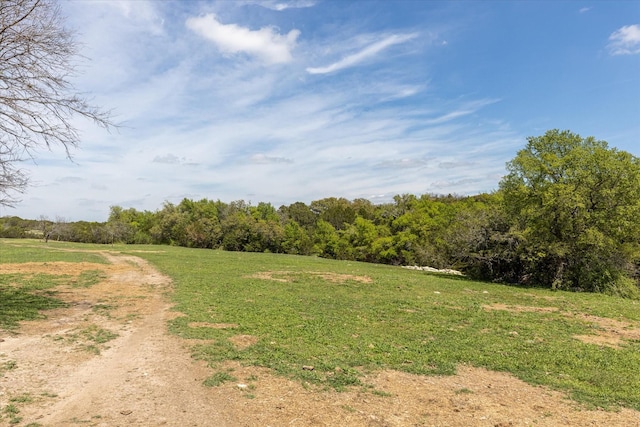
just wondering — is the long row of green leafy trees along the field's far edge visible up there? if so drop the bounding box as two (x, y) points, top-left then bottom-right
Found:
(0, 130), (640, 297)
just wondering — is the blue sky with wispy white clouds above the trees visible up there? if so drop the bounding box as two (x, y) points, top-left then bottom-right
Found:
(6, 0), (640, 221)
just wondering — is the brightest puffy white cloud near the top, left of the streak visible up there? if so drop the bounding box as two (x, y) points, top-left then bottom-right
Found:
(187, 14), (300, 64)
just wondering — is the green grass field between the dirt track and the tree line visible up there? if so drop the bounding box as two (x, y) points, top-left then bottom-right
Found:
(0, 240), (640, 410)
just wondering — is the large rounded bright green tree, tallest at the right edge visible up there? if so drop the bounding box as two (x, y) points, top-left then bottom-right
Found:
(500, 130), (640, 293)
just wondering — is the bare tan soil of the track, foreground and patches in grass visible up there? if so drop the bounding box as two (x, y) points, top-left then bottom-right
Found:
(0, 252), (640, 427)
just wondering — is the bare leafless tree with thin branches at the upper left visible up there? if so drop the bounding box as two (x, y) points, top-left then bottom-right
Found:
(0, 0), (113, 206)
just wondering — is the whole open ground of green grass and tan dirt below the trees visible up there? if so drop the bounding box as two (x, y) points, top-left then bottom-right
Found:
(0, 240), (640, 426)
